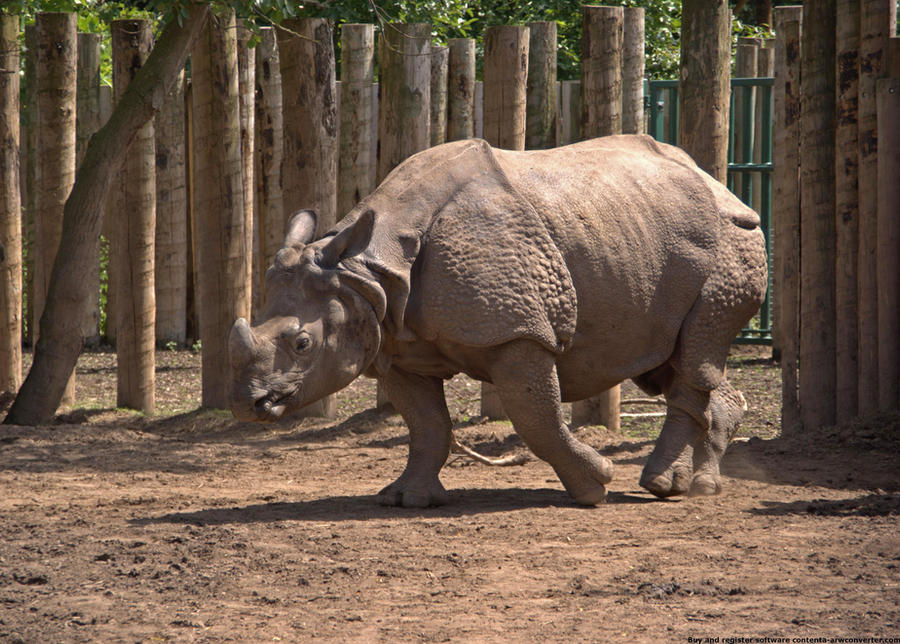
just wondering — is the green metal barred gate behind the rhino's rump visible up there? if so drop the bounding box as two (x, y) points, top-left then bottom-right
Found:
(644, 78), (775, 344)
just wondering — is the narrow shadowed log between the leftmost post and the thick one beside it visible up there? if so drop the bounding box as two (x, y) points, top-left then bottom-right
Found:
(20, 25), (37, 346)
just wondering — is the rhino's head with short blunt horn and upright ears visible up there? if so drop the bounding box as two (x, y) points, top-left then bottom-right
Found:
(229, 210), (381, 421)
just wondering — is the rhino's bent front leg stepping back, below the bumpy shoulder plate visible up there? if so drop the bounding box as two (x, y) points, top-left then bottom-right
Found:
(490, 340), (612, 505)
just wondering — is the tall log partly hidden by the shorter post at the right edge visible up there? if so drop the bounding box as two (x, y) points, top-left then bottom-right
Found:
(857, 0), (897, 415)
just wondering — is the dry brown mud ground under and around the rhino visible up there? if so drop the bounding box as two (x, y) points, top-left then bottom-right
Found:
(0, 348), (900, 642)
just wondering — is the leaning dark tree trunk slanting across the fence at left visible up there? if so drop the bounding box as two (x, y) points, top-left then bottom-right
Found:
(4, 3), (209, 425)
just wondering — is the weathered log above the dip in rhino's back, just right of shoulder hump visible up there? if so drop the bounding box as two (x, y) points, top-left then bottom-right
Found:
(525, 22), (559, 150)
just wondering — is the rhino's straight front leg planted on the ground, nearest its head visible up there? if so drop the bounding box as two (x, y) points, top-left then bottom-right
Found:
(378, 368), (453, 508)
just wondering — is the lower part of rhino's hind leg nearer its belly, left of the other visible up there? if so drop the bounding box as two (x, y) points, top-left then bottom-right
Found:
(641, 375), (711, 498)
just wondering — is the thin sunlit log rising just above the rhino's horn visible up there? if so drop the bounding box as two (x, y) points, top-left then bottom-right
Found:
(237, 20), (259, 320)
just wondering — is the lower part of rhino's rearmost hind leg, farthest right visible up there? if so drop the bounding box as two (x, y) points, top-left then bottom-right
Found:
(689, 380), (747, 496)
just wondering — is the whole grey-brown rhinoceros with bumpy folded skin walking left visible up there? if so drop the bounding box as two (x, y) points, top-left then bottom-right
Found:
(230, 136), (766, 507)
